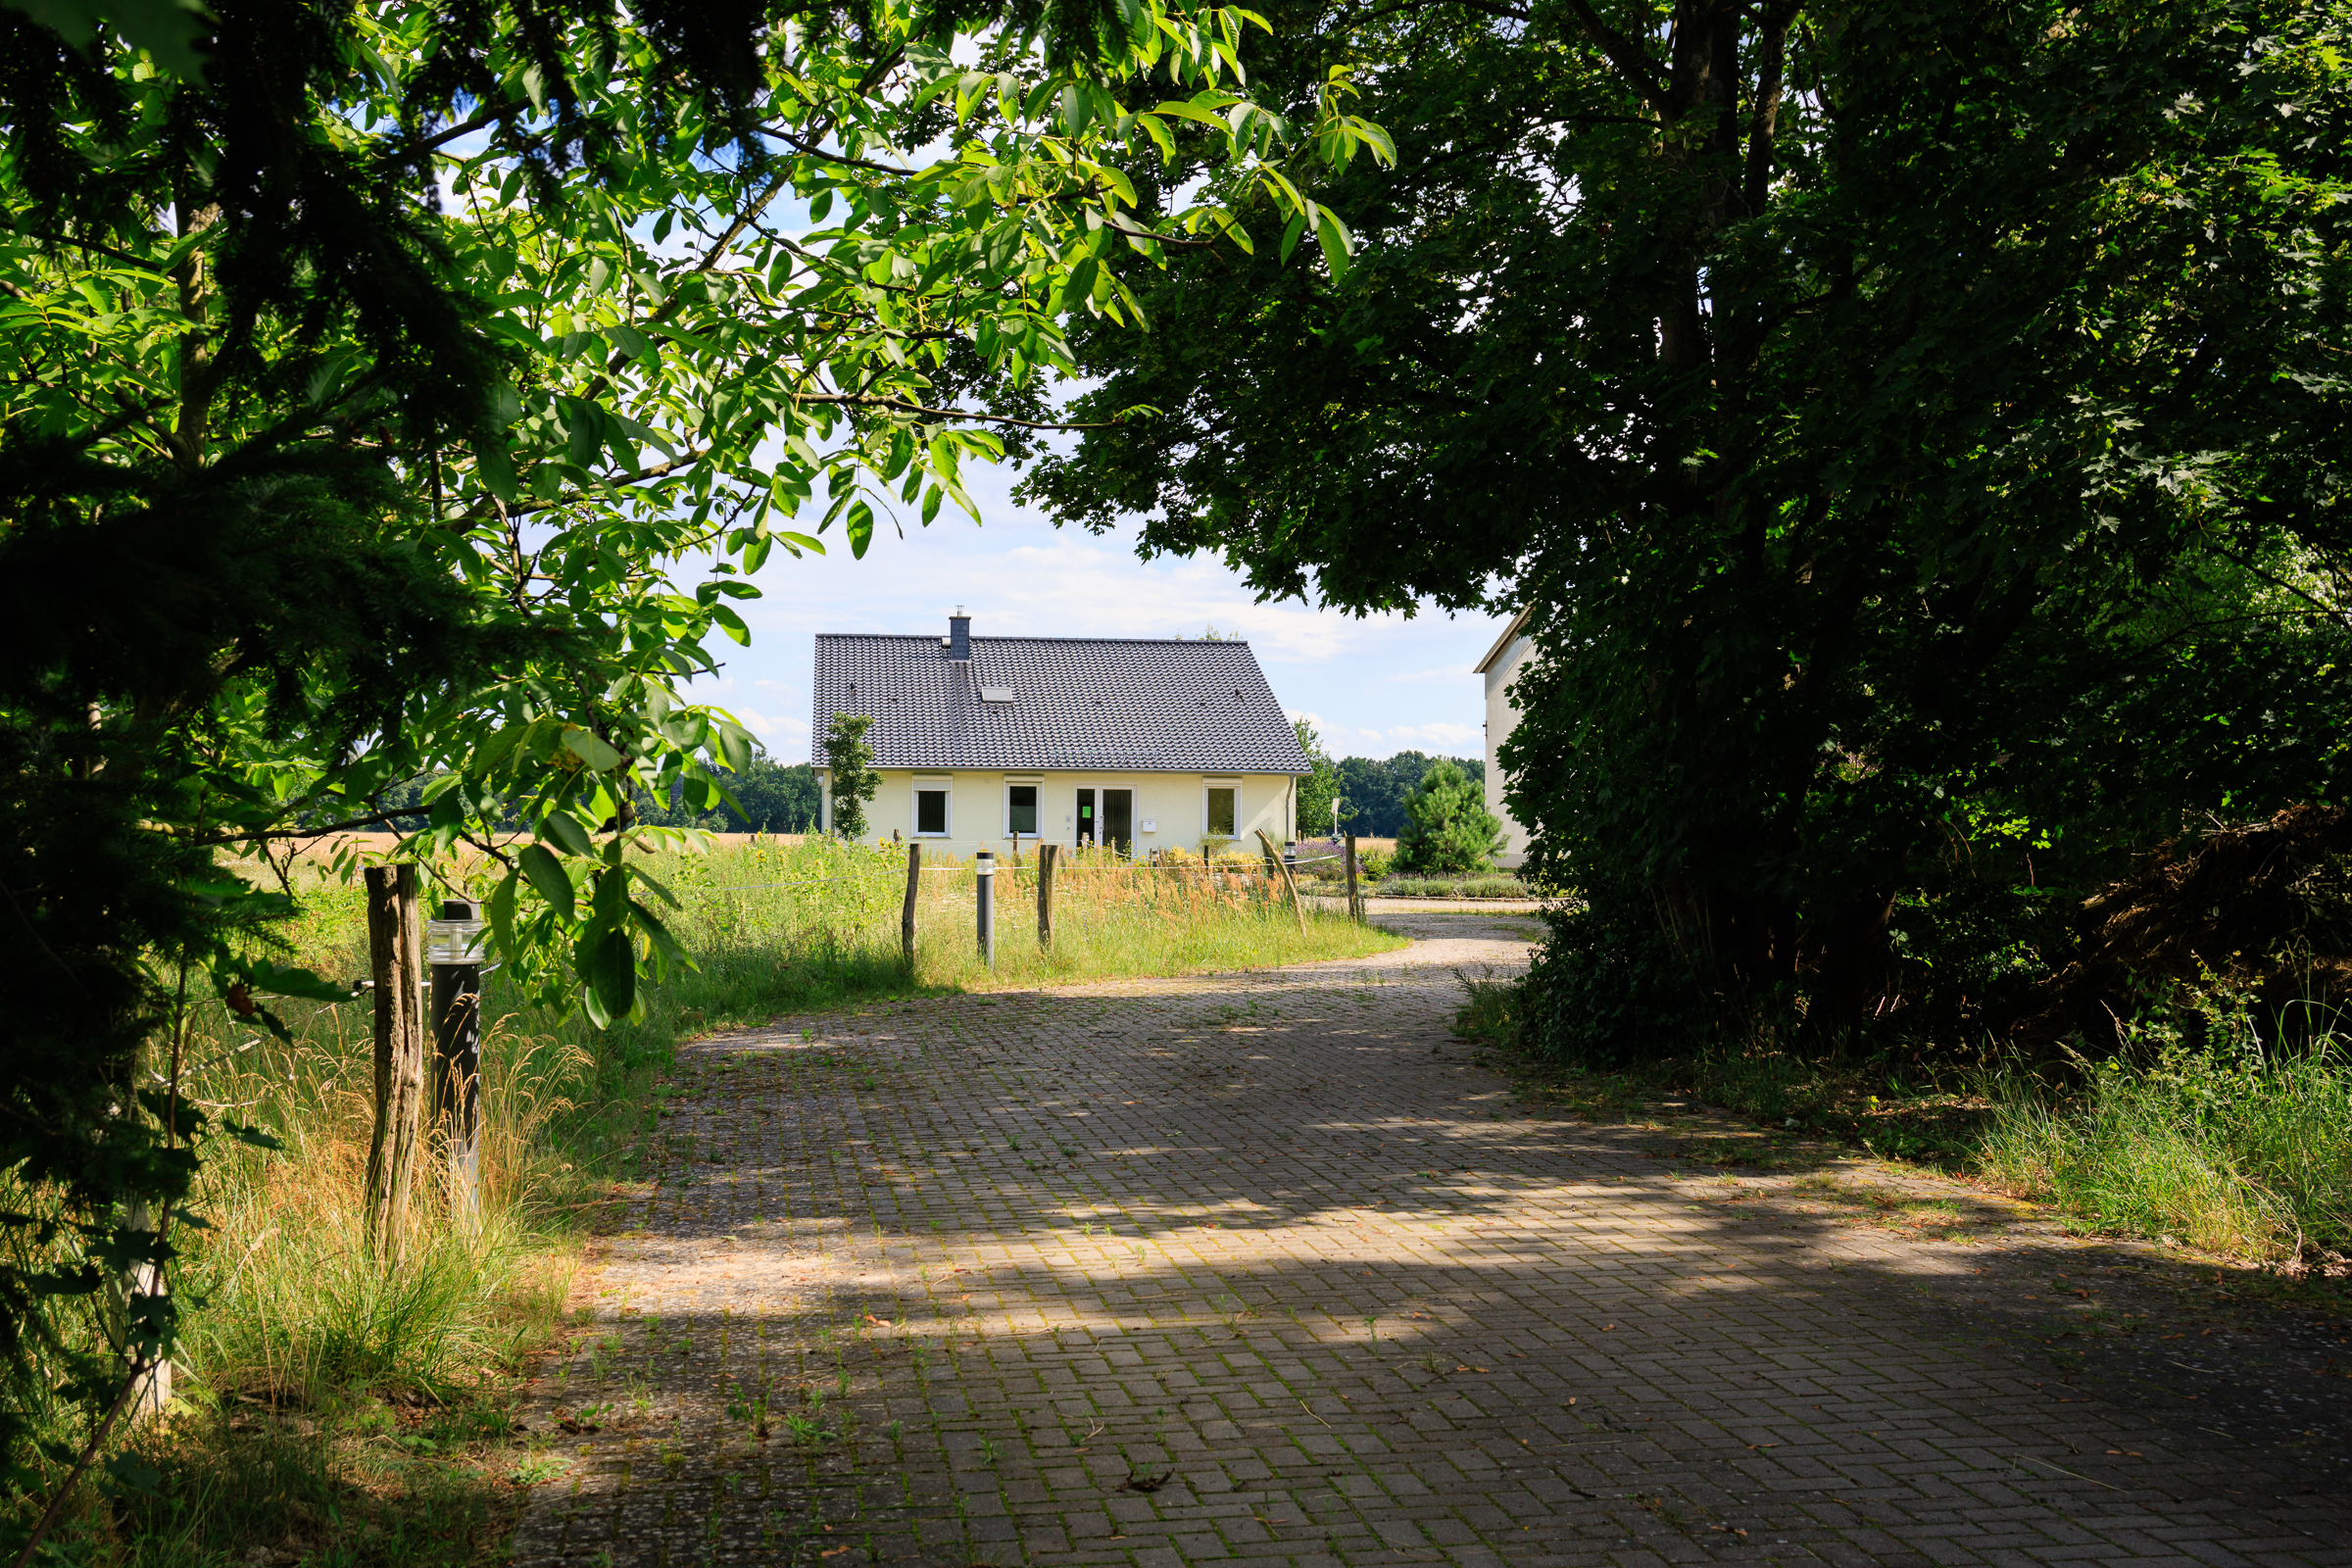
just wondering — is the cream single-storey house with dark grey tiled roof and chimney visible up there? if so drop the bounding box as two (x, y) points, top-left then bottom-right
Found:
(813, 612), (1310, 856)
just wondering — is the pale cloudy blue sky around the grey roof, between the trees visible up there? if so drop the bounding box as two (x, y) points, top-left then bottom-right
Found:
(694, 453), (1503, 761)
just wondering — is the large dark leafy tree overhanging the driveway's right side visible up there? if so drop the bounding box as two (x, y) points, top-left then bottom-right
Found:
(1028, 0), (2352, 1057)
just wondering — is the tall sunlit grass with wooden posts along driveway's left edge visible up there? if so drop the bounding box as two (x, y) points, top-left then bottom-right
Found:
(18, 842), (1404, 1568)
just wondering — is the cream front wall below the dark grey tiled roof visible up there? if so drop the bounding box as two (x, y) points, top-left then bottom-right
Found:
(816, 768), (1296, 856)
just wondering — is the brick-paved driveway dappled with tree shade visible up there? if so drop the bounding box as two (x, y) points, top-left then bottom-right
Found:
(515, 917), (2352, 1568)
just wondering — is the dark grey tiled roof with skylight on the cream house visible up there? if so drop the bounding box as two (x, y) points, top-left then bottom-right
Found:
(813, 635), (1310, 773)
